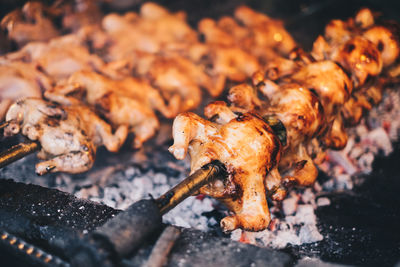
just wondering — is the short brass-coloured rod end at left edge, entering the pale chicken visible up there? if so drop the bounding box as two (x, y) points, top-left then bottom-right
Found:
(0, 142), (40, 169)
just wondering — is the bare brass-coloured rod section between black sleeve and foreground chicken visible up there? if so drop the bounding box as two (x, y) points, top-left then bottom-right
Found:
(156, 161), (226, 215)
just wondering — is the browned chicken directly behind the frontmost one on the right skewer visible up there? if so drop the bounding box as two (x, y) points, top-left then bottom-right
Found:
(228, 80), (325, 189)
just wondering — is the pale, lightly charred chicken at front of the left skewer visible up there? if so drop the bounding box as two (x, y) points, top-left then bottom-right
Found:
(4, 98), (128, 175)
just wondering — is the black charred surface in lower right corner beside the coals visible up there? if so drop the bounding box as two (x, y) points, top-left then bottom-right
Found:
(285, 144), (400, 266)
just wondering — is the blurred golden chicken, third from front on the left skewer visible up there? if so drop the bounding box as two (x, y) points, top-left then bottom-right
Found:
(114, 52), (225, 112)
